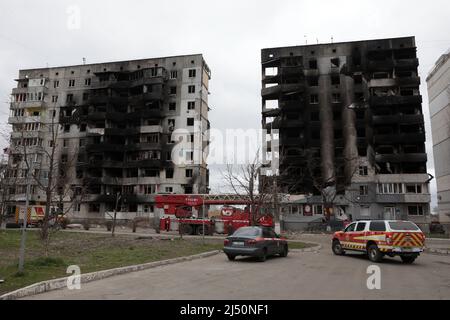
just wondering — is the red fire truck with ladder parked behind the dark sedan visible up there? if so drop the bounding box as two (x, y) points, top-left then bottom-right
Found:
(155, 194), (274, 235)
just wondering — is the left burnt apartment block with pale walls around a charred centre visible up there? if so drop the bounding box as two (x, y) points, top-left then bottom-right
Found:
(8, 54), (211, 219)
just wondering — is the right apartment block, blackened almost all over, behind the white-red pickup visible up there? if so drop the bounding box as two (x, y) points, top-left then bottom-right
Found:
(261, 37), (430, 228)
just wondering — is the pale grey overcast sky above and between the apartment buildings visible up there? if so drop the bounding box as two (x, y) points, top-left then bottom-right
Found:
(0, 0), (450, 206)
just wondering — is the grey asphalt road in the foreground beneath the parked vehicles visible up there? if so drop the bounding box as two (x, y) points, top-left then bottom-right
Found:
(28, 239), (450, 300)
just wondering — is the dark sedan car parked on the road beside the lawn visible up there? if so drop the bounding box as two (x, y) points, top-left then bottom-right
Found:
(223, 227), (288, 261)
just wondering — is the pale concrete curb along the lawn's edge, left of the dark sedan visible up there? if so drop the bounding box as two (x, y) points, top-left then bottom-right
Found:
(0, 250), (222, 300)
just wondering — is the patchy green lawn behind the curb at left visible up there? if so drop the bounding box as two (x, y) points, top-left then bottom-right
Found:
(0, 230), (223, 294)
